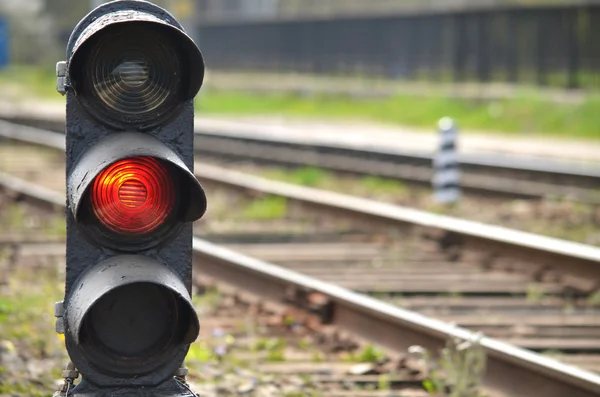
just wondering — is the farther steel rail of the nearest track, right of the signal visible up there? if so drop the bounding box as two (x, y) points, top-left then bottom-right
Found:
(195, 164), (600, 290)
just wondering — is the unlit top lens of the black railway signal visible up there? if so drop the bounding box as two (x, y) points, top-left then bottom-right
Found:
(82, 24), (182, 125)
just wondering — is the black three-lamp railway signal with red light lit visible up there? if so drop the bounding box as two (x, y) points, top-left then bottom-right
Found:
(56, 0), (206, 396)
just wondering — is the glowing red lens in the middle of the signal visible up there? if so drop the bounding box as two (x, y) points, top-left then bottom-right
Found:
(91, 157), (175, 235)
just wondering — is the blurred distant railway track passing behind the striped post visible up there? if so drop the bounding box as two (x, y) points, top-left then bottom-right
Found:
(0, 114), (600, 205)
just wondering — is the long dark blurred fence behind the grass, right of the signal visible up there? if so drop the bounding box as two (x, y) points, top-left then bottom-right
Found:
(198, 3), (600, 88)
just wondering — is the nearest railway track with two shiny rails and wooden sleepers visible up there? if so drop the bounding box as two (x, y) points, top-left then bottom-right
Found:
(4, 124), (600, 396)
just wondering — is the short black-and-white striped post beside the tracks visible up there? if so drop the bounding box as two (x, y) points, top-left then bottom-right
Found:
(432, 117), (460, 204)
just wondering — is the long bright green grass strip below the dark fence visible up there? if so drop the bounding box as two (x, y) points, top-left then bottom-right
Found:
(196, 91), (600, 139)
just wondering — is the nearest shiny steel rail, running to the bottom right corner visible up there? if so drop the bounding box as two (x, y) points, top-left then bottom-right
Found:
(0, 164), (600, 397)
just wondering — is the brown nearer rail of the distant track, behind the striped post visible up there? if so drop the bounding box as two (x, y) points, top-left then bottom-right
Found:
(195, 133), (600, 204)
